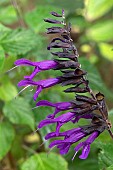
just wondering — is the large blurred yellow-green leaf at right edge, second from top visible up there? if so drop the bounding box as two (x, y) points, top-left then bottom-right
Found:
(86, 20), (113, 42)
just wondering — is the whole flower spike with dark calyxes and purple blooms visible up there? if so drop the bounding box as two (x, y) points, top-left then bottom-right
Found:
(15, 10), (113, 159)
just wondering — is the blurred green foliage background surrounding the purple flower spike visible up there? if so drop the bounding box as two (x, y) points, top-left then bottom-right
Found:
(0, 0), (113, 170)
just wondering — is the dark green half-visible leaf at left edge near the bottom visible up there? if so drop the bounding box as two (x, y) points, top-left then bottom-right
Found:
(0, 122), (15, 160)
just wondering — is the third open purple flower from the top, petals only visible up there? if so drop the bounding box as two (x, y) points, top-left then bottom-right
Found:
(36, 100), (72, 119)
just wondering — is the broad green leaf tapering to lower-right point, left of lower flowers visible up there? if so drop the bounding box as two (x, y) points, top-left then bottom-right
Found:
(3, 97), (35, 130)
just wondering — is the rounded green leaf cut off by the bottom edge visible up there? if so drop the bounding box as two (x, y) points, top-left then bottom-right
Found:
(21, 152), (68, 170)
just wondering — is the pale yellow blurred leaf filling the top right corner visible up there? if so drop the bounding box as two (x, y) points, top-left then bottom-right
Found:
(86, 0), (113, 20)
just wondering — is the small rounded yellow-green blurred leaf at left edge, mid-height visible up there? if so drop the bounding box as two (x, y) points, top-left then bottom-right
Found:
(0, 81), (17, 101)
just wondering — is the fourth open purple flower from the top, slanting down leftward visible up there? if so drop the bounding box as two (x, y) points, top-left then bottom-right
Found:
(38, 112), (75, 136)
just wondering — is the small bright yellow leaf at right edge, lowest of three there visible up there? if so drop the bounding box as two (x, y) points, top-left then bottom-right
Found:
(99, 43), (113, 61)
